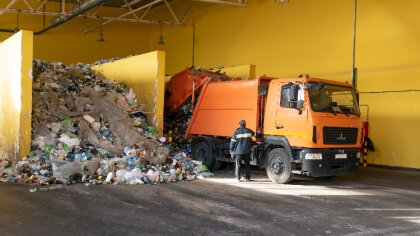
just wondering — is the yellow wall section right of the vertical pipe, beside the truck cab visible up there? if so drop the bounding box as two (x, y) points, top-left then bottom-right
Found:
(357, 0), (420, 168)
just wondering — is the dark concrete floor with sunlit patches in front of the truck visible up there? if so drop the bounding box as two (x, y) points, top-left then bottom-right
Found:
(0, 168), (420, 236)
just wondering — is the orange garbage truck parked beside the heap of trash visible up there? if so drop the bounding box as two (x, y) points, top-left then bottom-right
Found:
(185, 76), (363, 183)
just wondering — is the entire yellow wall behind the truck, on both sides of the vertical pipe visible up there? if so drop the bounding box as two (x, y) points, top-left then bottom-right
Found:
(149, 0), (420, 168)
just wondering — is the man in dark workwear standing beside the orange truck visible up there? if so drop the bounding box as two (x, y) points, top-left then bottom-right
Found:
(230, 120), (255, 181)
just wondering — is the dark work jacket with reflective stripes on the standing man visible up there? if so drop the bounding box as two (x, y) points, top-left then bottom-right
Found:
(230, 127), (255, 154)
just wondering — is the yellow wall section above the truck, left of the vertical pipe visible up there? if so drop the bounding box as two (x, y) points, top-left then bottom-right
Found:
(150, 0), (353, 78)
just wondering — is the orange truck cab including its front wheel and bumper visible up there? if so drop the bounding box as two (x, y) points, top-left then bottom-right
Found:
(261, 78), (362, 183)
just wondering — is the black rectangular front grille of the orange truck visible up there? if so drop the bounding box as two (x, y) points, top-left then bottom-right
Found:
(324, 127), (357, 144)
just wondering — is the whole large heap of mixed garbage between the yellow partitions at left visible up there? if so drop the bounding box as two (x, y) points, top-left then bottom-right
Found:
(0, 60), (211, 188)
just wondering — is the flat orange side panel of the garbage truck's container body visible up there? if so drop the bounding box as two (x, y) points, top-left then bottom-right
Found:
(186, 80), (259, 137)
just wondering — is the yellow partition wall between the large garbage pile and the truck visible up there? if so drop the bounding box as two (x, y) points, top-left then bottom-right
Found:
(92, 51), (165, 134)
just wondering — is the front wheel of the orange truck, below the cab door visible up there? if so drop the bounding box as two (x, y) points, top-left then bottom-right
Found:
(265, 148), (293, 184)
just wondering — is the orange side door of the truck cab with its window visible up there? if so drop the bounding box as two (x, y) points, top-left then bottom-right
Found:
(275, 83), (308, 147)
